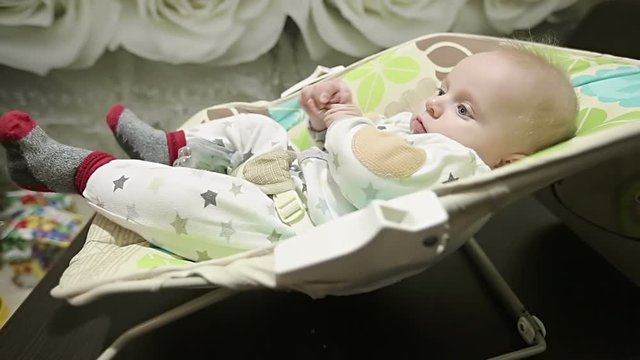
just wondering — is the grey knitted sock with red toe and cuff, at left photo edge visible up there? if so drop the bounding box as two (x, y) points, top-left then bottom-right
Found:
(0, 111), (114, 194)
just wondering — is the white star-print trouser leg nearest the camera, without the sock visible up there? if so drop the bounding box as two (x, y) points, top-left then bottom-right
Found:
(82, 159), (294, 261)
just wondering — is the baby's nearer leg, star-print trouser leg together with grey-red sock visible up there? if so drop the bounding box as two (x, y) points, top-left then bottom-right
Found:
(0, 112), (293, 260)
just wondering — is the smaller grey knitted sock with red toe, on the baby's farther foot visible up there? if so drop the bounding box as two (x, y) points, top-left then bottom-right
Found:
(107, 104), (186, 165)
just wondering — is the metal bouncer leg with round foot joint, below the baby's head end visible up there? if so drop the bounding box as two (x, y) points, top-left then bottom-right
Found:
(464, 238), (547, 360)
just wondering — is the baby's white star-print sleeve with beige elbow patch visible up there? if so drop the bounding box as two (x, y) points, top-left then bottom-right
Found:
(325, 117), (478, 208)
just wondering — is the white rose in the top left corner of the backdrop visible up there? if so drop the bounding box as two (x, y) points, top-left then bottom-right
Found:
(0, 0), (120, 75)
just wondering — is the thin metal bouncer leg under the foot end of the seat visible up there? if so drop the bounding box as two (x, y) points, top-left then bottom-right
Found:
(98, 288), (237, 360)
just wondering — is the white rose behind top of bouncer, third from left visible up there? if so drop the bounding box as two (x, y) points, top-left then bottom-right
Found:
(289, 0), (466, 59)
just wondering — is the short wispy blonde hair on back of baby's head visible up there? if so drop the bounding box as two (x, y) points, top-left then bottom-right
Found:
(495, 41), (579, 153)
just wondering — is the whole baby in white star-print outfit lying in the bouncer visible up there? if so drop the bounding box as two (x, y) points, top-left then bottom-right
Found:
(0, 49), (577, 261)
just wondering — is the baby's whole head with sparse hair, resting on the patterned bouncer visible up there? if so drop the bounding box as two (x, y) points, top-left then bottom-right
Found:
(411, 47), (578, 168)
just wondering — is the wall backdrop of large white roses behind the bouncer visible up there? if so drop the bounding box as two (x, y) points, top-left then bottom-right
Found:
(0, 0), (600, 192)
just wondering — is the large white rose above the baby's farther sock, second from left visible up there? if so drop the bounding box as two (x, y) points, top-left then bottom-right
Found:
(111, 0), (286, 65)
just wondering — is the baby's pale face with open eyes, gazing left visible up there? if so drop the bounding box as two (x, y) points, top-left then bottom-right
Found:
(411, 52), (540, 167)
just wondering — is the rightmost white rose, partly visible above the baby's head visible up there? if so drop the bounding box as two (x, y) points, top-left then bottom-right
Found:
(484, 0), (577, 34)
